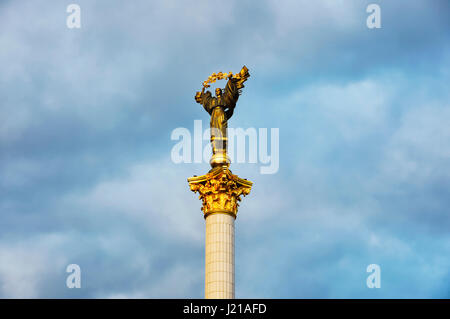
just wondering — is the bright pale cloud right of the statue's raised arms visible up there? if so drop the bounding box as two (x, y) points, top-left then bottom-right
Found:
(278, 78), (393, 141)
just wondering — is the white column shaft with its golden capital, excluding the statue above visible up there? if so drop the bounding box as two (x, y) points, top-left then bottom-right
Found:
(188, 165), (252, 299)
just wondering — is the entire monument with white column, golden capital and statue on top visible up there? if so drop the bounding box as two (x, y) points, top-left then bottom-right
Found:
(188, 66), (252, 299)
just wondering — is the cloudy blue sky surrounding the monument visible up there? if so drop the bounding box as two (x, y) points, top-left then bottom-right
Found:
(0, 0), (450, 298)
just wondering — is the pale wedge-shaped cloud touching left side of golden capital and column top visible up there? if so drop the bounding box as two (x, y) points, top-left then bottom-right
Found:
(62, 160), (203, 242)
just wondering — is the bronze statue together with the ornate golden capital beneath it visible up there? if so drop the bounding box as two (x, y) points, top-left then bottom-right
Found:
(188, 65), (252, 218)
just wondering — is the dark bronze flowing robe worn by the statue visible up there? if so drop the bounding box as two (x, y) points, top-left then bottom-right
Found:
(200, 79), (239, 154)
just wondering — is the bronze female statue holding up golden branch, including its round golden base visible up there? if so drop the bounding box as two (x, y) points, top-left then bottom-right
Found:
(195, 65), (250, 167)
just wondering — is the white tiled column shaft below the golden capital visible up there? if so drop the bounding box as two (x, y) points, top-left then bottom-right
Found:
(205, 213), (234, 299)
